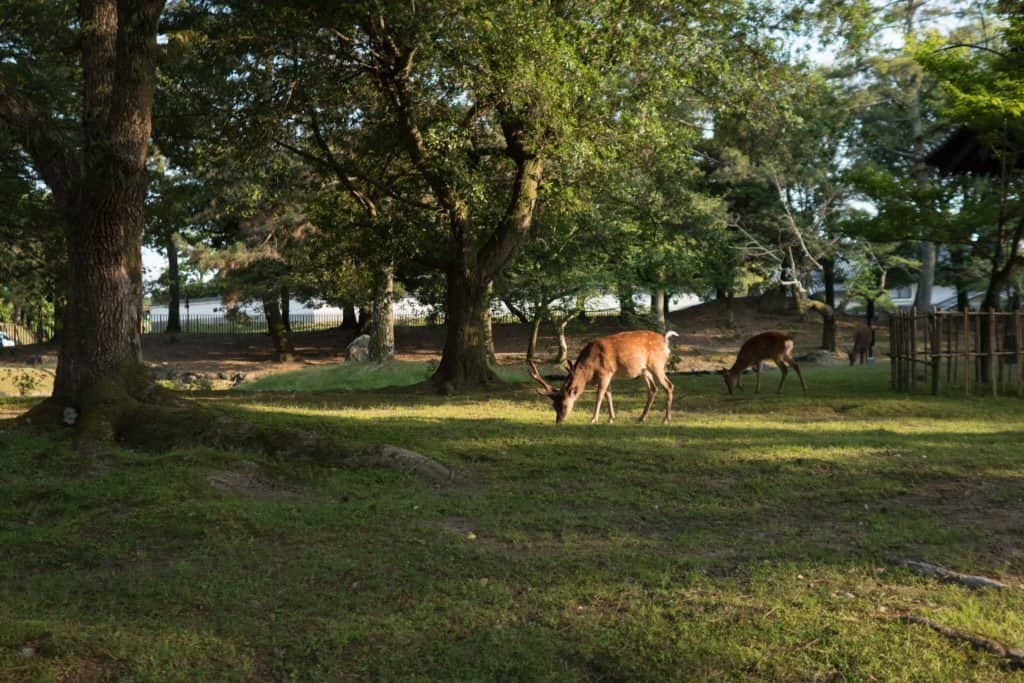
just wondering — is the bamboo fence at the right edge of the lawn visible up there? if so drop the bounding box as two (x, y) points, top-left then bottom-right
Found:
(889, 308), (1024, 397)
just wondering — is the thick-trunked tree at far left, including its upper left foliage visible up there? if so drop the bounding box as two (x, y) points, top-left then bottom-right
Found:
(0, 0), (164, 435)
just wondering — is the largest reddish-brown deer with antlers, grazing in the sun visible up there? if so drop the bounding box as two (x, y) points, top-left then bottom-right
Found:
(529, 330), (676, 423)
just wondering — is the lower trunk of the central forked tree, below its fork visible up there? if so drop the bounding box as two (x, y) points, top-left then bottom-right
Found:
(432, 266), (498, 389)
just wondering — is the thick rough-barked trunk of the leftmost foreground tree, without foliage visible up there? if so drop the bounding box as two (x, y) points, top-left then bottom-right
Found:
(37, 0), (164, 438)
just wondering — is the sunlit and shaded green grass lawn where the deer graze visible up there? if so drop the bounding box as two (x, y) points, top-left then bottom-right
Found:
(0, 365), (1024, 682)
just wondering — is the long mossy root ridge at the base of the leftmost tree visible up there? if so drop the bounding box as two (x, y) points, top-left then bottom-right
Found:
(23, 384), (454, 483)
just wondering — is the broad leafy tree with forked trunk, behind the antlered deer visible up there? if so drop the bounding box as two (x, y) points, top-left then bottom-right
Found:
(169, 0), (777, 385)
